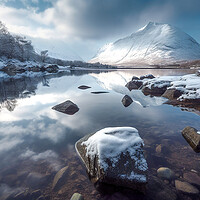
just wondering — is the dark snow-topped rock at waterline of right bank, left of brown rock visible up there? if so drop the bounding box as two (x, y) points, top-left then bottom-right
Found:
(142, 85), (167, 96)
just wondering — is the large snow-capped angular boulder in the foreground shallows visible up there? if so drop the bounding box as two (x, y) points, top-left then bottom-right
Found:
(76, 127), (148, 192)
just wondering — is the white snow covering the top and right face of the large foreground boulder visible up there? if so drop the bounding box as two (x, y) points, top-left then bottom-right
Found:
(81, 127), (148, 182)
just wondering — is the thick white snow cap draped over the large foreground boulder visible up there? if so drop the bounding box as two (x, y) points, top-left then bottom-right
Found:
(81, 127), (148, 176)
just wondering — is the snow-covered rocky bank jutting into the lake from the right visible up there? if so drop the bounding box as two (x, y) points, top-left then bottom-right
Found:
(126, 71), (200, 110)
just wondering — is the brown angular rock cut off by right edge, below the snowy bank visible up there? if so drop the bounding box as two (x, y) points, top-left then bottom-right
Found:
(182, 126), (200, 153)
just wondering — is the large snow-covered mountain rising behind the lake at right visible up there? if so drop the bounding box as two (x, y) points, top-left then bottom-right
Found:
(90, 22), (200, 66)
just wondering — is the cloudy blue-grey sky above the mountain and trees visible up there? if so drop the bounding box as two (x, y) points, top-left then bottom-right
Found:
(0, 0), (200, 60)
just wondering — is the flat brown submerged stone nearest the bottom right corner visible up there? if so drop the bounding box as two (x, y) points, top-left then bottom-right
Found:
(175, 180), (199, 194)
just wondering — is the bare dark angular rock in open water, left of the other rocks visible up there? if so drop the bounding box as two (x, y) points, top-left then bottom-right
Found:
(52, 100), (79, 115)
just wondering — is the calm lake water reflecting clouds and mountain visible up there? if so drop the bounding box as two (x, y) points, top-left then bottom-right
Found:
(0, 70), (200, 200)
